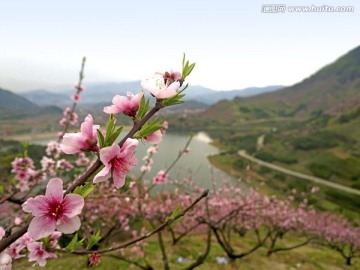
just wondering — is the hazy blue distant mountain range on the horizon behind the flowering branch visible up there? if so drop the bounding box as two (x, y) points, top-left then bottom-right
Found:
(21, 81), (282, 106)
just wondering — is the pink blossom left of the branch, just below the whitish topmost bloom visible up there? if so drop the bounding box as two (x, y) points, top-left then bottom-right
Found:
(104, 92), (144, 117)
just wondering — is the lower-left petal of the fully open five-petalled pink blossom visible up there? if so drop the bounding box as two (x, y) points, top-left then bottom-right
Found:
(28, 216), (56, 240)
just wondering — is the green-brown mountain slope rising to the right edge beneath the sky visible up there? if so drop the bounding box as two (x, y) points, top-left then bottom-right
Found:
(203, 46), (360, 121)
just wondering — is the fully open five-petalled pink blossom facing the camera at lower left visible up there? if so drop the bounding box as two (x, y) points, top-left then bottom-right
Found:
(22, 178), (84, 240)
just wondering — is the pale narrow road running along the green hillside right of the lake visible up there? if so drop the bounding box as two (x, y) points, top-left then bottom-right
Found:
(238, 150), (360, 195)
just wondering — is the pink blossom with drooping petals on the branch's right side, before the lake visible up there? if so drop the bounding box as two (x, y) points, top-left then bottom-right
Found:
(93, 138), (139, 188)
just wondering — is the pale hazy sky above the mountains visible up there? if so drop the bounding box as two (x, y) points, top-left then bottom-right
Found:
(0, 0), (360, 90)
